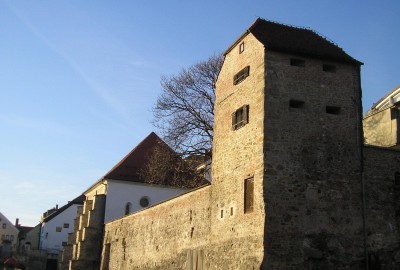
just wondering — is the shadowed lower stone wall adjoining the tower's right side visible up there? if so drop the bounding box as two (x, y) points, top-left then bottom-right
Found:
(364, 147), (400, 270)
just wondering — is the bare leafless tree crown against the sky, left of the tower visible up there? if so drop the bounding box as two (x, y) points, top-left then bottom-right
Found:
(153, 55), (223, 159)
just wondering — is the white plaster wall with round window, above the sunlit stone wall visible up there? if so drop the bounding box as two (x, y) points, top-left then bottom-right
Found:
(104, 180), (187, 223)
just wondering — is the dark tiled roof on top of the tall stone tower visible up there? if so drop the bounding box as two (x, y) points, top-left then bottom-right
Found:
(226, 18), (362, 65)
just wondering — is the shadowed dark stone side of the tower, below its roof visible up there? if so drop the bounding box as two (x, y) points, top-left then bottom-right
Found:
(264, 51), (363, 269)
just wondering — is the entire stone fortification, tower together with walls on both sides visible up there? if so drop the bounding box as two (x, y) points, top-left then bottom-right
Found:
(101, 19), (400, 270)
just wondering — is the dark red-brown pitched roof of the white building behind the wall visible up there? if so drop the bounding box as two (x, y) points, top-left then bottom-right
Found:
(102, 132), (208, 188)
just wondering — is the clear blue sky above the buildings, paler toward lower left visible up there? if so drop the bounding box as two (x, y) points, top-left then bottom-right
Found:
(0, 0), (400, 226)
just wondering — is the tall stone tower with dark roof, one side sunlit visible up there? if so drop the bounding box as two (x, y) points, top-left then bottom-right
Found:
(211, 19), (364, 269)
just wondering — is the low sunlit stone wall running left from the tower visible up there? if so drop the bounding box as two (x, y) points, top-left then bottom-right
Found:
(101, 186), (211, 270)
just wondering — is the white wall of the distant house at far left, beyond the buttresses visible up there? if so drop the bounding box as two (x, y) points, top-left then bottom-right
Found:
(40, 204), (78, 254)
